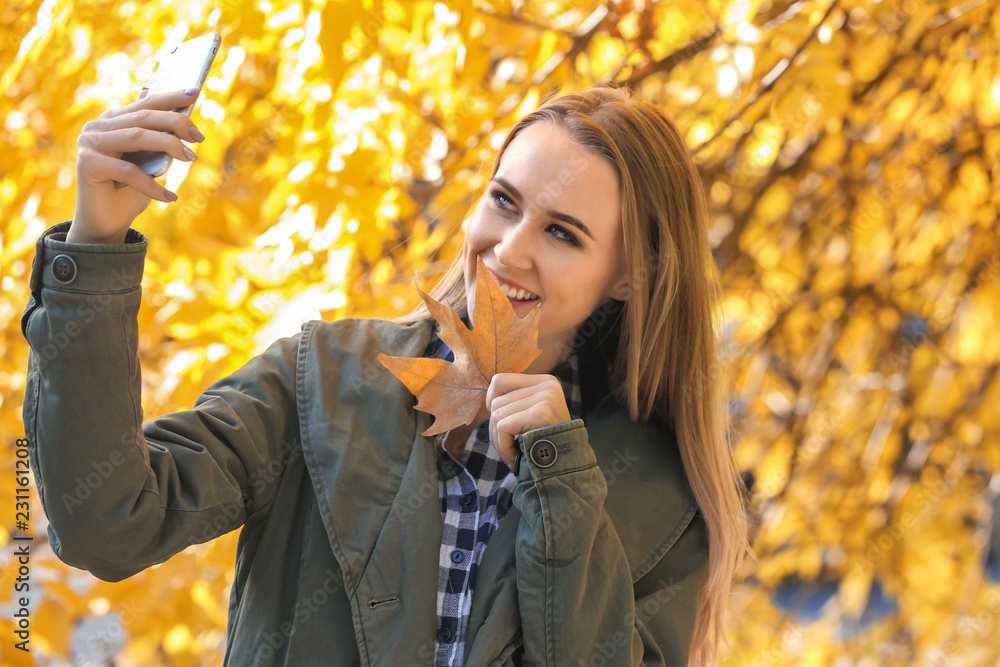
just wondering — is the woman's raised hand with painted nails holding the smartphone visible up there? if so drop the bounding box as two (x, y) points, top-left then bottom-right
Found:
(66, 89), (205, 243)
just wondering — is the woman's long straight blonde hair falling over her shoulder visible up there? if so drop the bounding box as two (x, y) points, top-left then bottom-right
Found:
(398, 88), (752, 665)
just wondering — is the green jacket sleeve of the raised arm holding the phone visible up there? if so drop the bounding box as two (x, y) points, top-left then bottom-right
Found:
(21, 223), (298, 581)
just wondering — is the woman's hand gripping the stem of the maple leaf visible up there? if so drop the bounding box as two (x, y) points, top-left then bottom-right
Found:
(486, 373), (570, 469)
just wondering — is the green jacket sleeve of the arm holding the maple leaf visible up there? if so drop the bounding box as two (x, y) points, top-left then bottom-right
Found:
(513, 419), (707, 667)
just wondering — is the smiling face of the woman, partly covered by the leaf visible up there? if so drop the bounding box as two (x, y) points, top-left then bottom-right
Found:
(465, 121), (624, 366)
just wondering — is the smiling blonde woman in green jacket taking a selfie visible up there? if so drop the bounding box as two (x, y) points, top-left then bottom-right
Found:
(22, 89), (747, 665)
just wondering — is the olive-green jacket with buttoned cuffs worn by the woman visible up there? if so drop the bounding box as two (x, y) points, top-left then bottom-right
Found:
(22, 223), (708, 667)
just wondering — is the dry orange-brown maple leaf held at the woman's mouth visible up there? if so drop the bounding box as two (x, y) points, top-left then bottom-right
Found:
(376, 260), (542, 435)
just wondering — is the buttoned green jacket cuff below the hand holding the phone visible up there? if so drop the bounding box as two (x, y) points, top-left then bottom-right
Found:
(30, 222), (147, 295)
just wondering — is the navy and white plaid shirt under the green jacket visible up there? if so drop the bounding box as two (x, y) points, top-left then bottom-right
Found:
(425, 336), (582, 667)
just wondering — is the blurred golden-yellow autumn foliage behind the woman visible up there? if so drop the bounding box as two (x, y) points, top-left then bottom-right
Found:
(0, 0), (1000, 667)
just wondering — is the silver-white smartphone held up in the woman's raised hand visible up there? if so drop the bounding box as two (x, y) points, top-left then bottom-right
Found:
(115, 32), (222, 188)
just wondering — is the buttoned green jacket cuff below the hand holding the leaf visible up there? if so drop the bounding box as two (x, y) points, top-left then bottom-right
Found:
(514, 419), (597, 482)
